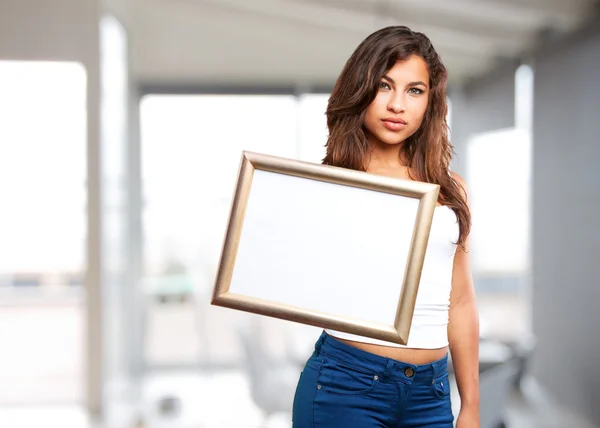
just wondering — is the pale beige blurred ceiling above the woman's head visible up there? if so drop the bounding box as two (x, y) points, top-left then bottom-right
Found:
(108, 0), (598, 89)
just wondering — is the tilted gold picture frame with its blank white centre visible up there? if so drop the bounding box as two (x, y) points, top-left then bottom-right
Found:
(211, 151), (439, 344)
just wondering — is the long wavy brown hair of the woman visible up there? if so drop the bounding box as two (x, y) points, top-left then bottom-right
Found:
(323, 26), (471, 247)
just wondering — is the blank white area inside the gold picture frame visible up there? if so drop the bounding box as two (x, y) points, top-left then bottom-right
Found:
(229, 169), (419, 325)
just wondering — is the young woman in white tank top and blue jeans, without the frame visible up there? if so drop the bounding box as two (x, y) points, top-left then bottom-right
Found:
(293, 26), (479, 428)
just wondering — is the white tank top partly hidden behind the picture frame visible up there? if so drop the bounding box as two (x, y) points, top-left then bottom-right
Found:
(326, 206), (459, 349)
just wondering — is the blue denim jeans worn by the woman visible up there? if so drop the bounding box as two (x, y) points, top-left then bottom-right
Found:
(292, 332), (454, 428)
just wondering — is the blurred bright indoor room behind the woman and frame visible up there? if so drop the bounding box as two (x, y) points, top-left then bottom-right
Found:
(0, 0), (600, 428)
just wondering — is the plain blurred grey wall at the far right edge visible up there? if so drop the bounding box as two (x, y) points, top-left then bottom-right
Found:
(531, 26), (600, 425)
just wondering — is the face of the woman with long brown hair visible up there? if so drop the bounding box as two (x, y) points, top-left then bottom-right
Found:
(364, 55), (430, 145)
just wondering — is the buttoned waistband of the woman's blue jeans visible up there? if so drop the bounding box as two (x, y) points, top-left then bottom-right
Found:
(315, 332), (448, 383)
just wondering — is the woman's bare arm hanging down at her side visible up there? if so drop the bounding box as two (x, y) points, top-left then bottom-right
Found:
(448, 173), (479, 428)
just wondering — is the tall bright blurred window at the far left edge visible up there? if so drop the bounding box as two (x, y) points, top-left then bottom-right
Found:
(0, 61), (87, 404)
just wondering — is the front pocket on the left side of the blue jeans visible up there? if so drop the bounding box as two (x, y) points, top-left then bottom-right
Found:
(317, 360), (379, 395)
